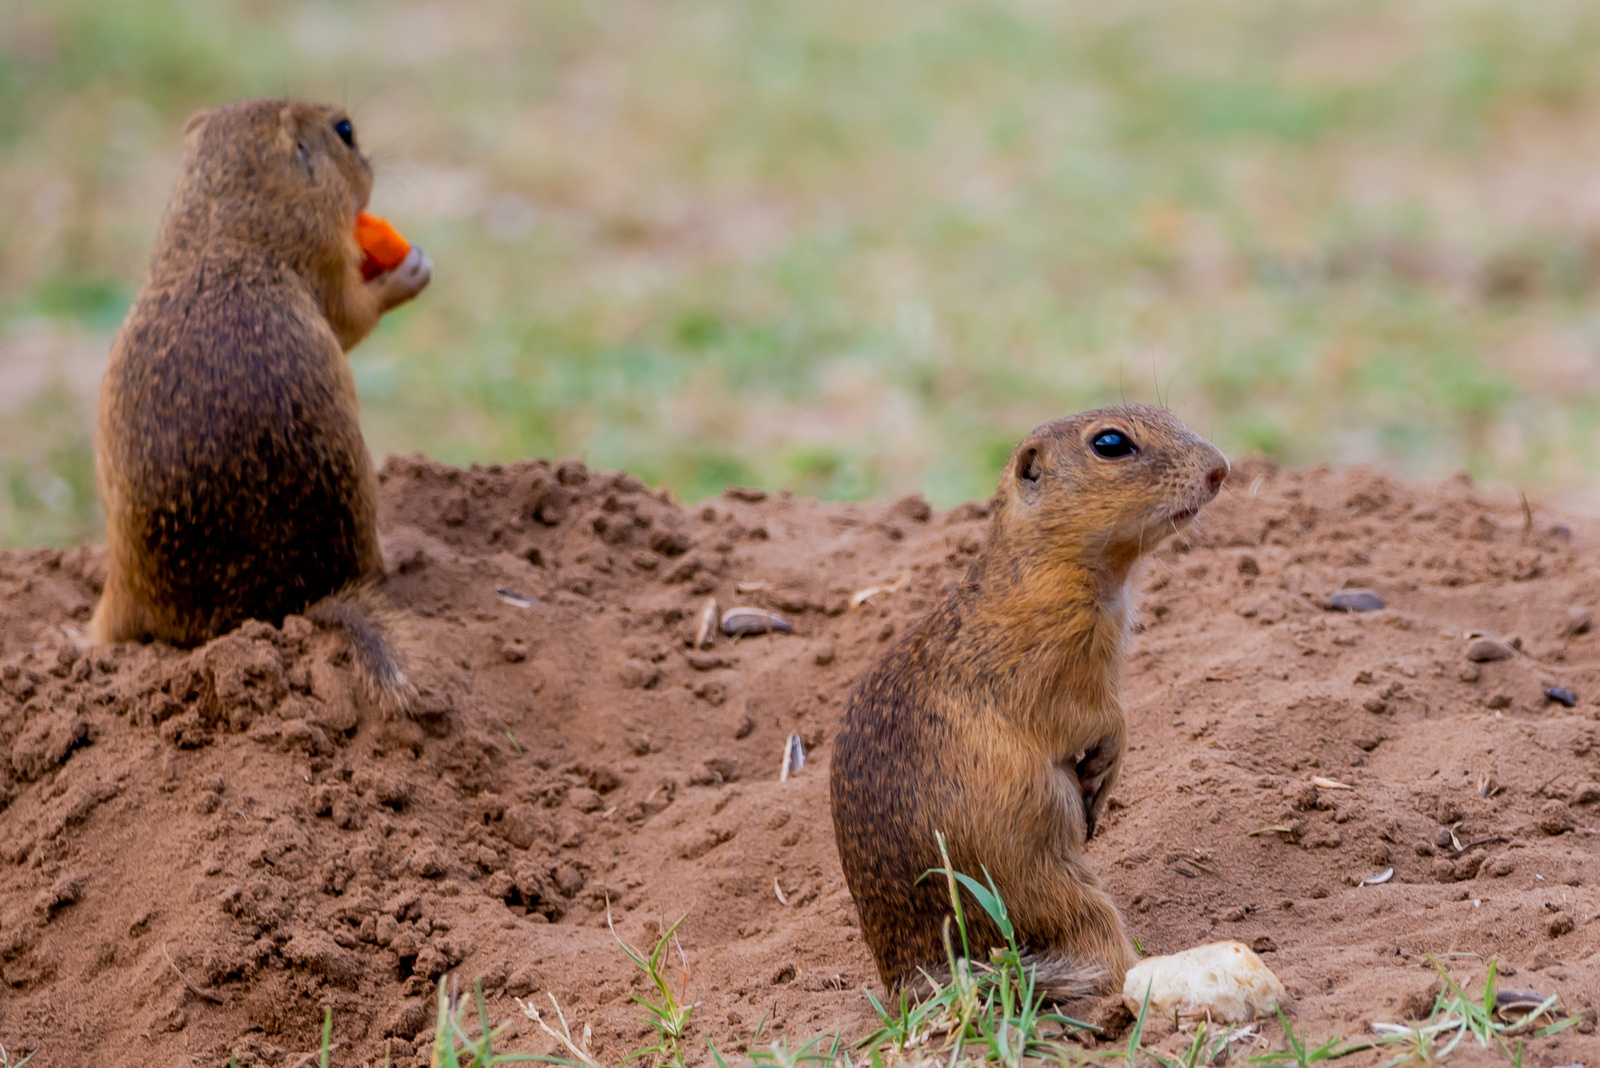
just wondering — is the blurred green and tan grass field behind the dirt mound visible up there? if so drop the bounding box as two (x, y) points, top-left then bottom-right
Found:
(9, 0), (1600, 544)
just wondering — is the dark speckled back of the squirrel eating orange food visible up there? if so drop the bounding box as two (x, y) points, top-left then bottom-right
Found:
(101, 259), (382, 644)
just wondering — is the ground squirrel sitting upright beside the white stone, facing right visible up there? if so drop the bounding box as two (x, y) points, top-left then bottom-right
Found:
(832, 406), (1229, 996)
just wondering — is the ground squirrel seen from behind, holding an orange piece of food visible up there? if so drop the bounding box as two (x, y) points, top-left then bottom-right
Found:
(90, 101), (434, 711)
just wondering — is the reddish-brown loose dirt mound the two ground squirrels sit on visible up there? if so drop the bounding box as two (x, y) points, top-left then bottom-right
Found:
(0, 459), (1600, 1065)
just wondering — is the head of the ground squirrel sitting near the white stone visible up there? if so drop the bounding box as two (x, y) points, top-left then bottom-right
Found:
(995, 404), (1229, 574)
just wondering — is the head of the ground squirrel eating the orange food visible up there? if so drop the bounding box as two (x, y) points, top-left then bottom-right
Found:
(174, 101), (373, 265)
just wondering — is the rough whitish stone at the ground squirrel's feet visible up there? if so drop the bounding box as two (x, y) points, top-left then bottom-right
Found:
(1122, 942), (1288, 1023)
